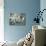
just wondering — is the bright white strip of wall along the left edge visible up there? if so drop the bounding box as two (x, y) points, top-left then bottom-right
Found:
(0, 0), (4, 42)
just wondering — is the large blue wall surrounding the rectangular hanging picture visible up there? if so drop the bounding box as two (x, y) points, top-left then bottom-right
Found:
(4, 0), (40, 41)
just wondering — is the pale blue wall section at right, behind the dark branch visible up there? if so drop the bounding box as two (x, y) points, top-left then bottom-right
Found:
(40, 0), (46, 27)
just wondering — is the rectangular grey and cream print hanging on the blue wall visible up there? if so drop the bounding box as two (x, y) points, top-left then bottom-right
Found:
(9, 13), (26, 25)
